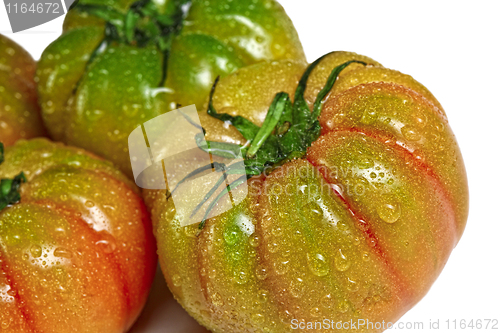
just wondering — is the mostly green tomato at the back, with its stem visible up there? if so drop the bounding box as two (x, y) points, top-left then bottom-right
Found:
(37, 0), (305, 176)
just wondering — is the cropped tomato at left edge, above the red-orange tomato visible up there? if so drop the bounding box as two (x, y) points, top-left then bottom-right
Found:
(0, 35), (46, 146)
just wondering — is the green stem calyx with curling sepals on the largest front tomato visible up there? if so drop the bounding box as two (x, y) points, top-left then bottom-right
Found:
(167, 54), (367, 231)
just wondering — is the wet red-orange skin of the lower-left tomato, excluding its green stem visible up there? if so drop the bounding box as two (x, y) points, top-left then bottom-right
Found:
(0, 139), (156, 333)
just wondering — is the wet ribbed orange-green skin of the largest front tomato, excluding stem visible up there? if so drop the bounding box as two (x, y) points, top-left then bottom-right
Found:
(145, 52), (468, 332)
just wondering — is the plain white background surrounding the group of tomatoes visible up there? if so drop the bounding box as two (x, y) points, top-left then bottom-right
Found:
(0, 0), (500, 333)
